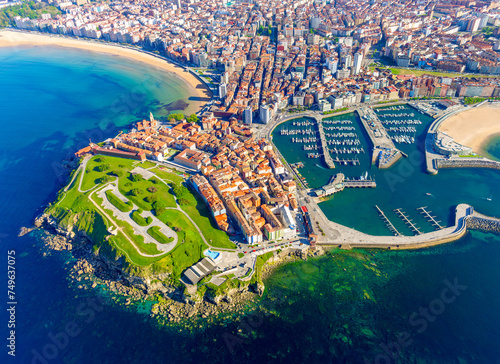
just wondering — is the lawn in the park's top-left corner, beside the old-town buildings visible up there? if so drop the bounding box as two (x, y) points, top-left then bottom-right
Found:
(78, 155), (138, 191)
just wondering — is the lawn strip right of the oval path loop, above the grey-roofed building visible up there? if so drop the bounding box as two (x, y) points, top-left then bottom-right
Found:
(159, 209), (208, 279)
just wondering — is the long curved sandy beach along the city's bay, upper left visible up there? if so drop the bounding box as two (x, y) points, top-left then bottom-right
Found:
(0, 30), (211, 115)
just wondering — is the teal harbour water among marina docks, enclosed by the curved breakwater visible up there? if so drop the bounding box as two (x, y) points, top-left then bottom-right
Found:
(274, 105), (497, 242)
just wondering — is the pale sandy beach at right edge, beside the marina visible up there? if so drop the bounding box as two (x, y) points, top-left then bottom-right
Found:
(439, 105), (500, 154)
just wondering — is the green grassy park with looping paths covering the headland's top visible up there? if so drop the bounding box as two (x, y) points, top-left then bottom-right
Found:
(46, 156), (235, 283)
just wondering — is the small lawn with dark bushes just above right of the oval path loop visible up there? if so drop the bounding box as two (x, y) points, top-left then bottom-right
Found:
(118, 173), (177, 211)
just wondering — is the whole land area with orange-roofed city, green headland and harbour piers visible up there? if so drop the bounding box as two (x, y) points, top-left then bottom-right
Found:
(4, 0), (500, 322)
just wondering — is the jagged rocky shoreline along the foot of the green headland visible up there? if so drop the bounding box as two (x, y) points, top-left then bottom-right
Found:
(24, 214), (308, 329)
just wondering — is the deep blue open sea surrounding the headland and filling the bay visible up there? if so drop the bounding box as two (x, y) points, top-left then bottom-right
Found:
(0, 47), (500, 364)
